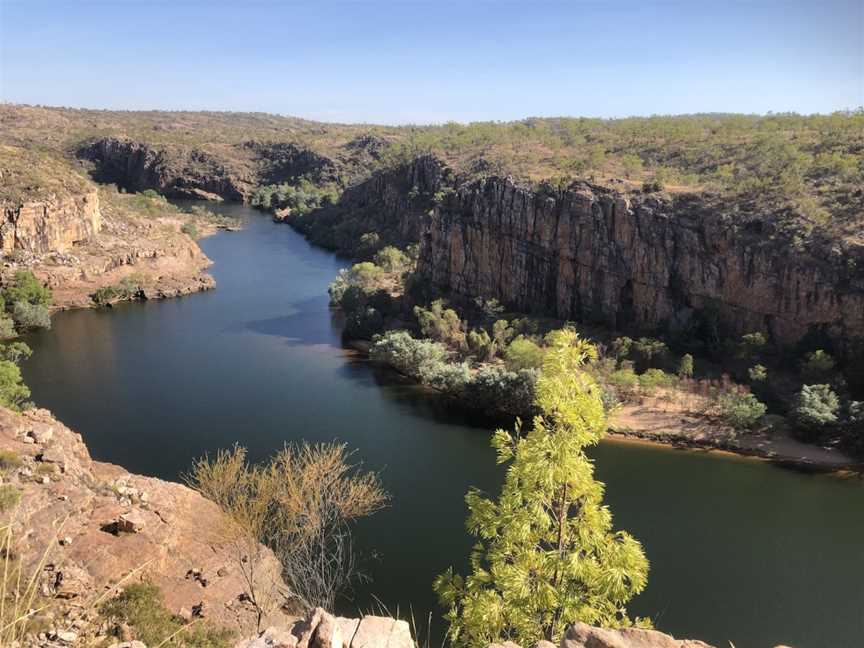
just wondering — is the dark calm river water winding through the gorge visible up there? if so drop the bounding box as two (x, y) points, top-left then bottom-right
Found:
(24, 205), (864, 648)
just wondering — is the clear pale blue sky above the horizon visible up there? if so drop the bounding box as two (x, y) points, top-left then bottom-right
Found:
(0, 0), (864, 123)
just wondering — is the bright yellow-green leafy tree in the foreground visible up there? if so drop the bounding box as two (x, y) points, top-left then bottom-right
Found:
(434, 329), (648, 646)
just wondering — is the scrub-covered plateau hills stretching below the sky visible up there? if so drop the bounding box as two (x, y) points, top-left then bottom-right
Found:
(0, 105), (864, 239)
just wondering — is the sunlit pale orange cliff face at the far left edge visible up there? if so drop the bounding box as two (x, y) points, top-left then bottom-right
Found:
(0, 190), (102, 254)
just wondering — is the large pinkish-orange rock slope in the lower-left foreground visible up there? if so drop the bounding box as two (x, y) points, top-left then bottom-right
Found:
(0, 408), (289, 645)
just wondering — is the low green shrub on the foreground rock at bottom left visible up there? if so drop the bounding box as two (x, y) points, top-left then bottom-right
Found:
(100, 582), (233, 648)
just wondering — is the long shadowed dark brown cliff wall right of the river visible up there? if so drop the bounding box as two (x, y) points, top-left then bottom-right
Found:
(418, 177), (864, 345)
